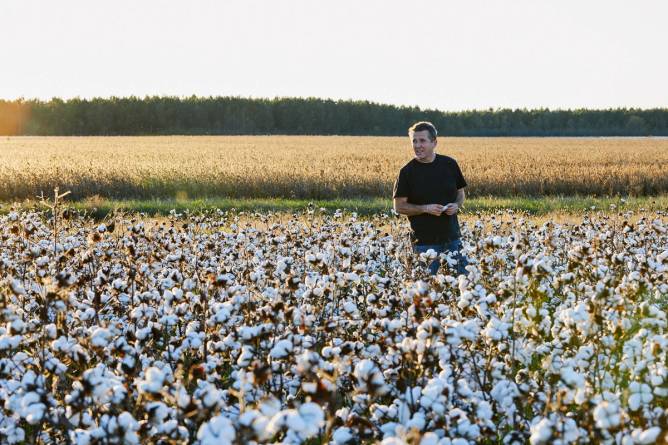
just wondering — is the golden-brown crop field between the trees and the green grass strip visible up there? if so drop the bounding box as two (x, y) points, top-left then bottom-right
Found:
(0, 136), (668, 201)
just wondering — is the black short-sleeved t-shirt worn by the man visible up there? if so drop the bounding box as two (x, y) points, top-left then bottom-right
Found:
(393, 154), (466, 244)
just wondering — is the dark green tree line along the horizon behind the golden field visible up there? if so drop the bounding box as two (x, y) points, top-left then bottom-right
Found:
(0, 96), (668, 136)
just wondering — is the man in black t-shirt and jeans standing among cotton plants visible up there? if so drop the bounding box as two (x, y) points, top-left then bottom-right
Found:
(393, 122), (468, 275)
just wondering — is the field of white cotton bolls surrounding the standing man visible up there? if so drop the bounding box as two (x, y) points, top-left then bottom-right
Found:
(0, 208), (668, 445)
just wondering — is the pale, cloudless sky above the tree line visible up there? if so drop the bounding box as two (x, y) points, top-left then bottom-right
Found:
(0, 0), (668, 110)
